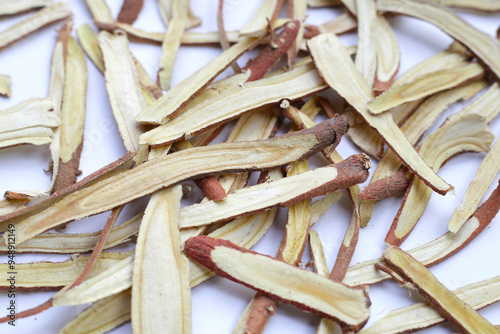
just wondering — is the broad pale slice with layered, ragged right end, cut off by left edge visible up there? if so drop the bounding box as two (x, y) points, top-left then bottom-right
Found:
(0, 98), (60, 148)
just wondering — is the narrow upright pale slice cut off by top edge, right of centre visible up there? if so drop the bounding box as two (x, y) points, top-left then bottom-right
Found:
(355, 0), (378, 88)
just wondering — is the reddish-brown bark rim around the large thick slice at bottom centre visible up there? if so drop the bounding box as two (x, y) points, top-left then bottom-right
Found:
(184, 235), (369, 331)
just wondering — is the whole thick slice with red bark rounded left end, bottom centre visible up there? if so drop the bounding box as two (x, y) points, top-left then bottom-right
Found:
(185, 236), (370, 330)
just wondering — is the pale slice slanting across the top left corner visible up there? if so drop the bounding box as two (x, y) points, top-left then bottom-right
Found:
(0, 2), (72, 50)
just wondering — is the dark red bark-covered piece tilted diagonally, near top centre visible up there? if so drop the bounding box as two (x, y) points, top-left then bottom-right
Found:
(243, 20), (300, 82)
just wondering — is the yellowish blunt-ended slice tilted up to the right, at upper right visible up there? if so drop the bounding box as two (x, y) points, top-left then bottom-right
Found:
(368, 63), (484, 114)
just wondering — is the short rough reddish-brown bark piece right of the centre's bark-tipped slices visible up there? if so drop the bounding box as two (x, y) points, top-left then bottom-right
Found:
(358, 168), (410, 201)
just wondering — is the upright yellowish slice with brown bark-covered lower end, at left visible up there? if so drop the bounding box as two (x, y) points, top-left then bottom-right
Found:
(52, 36), (87, 192)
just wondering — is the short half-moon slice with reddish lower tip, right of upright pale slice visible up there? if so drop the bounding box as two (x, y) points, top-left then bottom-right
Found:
(373, 14), (400, 95)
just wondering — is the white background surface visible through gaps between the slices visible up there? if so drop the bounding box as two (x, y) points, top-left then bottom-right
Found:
(0, 0), (500, 333)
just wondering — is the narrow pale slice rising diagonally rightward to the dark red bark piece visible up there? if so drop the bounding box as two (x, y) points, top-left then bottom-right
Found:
(136, 38), (259, 124)
